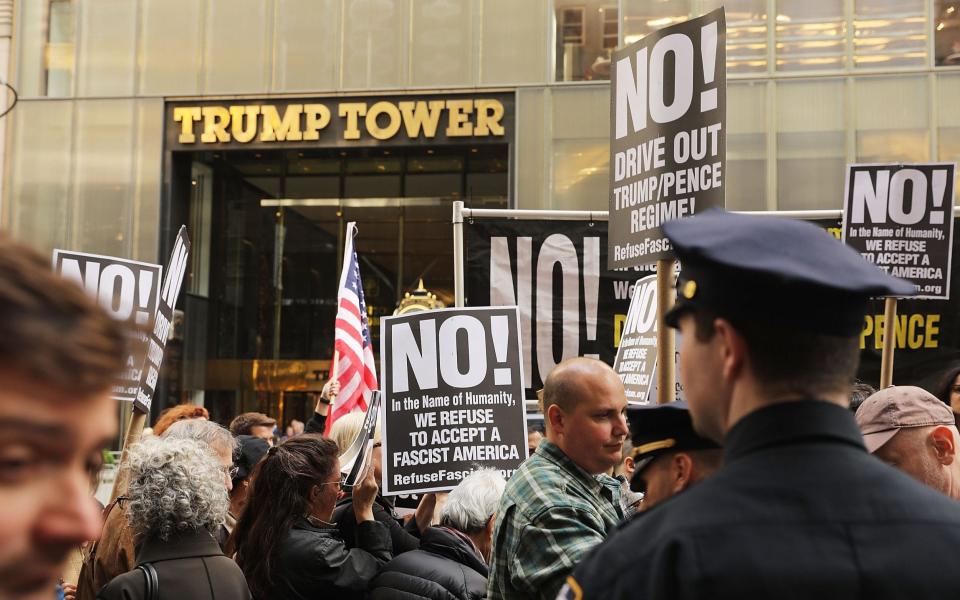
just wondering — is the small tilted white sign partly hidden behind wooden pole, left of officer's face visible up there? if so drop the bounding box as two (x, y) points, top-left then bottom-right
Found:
(613, 275), (657, 404)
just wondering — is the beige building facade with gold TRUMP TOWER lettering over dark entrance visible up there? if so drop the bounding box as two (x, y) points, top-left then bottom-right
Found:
(0, 0), (960, 428)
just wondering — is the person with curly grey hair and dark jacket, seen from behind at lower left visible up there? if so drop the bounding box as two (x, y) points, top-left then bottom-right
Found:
(97, 438), (250, 600)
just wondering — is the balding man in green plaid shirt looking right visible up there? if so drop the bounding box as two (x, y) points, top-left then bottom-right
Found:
(487, 358), (629, 600)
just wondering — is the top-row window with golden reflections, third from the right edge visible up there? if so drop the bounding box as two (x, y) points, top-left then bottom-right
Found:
(777, 0), (846, 71)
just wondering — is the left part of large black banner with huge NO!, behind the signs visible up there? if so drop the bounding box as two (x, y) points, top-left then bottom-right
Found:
(464, 219), (638, 399)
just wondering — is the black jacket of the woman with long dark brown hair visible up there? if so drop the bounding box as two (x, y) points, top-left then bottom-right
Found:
(260, 519), (391, 600)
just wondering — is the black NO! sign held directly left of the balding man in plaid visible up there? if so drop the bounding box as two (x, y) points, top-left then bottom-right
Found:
(380, 307), (527, 494)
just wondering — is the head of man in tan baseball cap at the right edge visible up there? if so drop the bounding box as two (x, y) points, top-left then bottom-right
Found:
(857, 385), (960, 500)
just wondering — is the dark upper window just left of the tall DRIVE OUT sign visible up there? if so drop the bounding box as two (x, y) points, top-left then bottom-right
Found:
(553, 0), (620, 81)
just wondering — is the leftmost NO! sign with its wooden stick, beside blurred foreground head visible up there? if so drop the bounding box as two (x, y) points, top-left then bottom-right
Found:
(53, 250), (162, 401)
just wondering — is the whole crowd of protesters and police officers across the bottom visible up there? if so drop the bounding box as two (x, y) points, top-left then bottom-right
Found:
(7, 207), (960, 600)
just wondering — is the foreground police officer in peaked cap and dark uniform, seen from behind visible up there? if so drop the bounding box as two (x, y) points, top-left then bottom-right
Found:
(561, 211), (960, 600)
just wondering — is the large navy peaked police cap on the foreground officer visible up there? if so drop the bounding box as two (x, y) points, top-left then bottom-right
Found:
(663, 210), (915, 336)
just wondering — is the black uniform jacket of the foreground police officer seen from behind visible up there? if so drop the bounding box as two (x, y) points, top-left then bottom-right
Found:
(561, 401), (960, 600)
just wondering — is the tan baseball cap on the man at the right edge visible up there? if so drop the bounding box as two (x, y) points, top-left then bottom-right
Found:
(857, 385), (955, 453)
